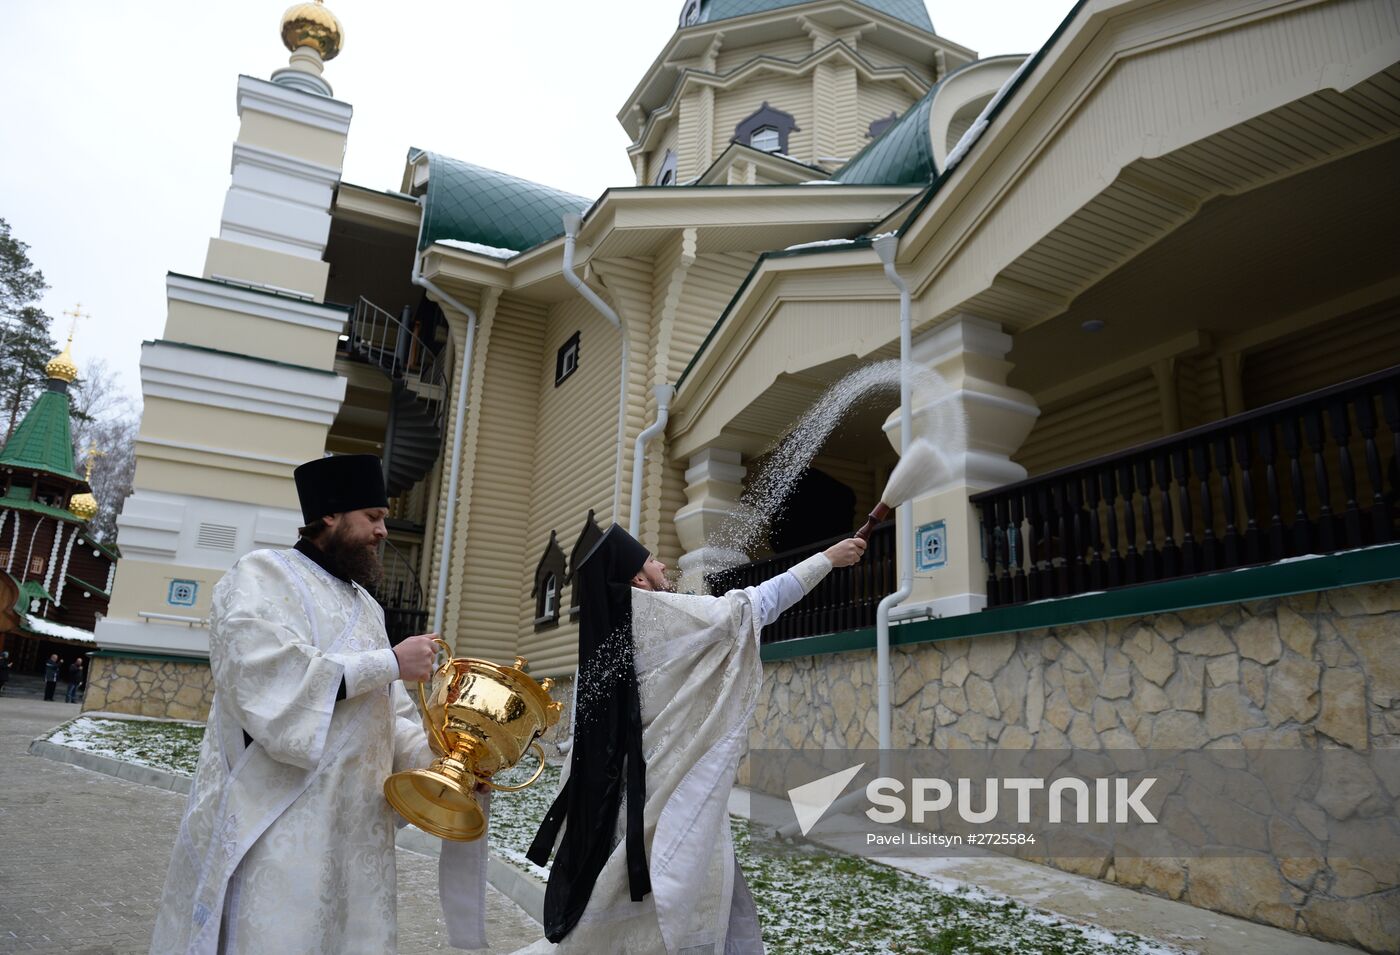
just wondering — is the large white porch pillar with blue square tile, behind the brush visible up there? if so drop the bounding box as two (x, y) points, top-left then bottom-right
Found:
(885, 315), (1040, 618)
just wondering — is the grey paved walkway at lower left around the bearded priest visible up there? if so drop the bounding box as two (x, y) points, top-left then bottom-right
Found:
(0, 693), (542, 955)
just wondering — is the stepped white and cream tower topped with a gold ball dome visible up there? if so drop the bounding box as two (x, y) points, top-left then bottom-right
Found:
(90, 0), (351, 718)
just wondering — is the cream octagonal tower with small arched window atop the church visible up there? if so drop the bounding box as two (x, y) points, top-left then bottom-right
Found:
(617, 0), (976, 186)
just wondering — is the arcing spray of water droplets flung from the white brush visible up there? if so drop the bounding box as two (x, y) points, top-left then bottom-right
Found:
(704, 358), (967, 576)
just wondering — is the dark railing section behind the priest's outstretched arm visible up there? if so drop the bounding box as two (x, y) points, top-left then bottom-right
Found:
(708, 521), (896, 643)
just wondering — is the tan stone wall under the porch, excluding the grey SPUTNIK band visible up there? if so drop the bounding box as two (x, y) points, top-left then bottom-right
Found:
(741, 581), (1400, 952)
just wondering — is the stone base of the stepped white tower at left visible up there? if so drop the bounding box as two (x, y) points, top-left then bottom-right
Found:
(83, 655), (214, 720)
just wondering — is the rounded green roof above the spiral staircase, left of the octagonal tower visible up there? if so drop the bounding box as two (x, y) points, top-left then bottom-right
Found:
(409, 150), (591, 252)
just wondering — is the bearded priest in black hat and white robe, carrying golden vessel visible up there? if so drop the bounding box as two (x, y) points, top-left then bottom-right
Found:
(151, 455), (486, 955)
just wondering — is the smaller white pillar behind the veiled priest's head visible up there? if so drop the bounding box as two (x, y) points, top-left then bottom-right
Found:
(675, 448), (749, 594)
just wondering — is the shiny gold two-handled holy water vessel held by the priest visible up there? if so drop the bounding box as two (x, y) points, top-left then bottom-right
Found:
(384, 640), (563, 842)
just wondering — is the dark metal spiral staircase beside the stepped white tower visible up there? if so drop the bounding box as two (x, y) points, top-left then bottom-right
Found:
(340, 295), (447, 499)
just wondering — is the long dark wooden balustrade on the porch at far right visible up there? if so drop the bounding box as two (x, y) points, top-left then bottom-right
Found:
(972, 367), (1400, 606)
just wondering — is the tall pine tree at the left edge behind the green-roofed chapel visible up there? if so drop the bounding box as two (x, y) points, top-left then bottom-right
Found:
(0, 218), (56, 445)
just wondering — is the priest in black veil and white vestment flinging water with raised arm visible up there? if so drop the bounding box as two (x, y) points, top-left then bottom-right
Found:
(522, 525), (865, 955)
